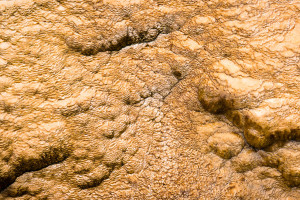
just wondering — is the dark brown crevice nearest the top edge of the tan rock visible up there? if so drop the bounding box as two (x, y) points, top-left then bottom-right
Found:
(65, 15), (186, 56)
